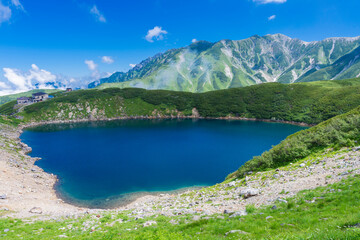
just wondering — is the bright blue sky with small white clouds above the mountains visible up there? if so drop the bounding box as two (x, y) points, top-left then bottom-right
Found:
(0, 0), (360, 94)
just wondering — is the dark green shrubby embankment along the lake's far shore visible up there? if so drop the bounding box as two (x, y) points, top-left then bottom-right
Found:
(4, 79), (360, 124)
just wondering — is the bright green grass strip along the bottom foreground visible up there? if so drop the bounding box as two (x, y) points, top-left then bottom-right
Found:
(0, 175), (360, 239)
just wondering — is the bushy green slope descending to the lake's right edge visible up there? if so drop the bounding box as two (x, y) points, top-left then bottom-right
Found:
(228, 104), (360, 178)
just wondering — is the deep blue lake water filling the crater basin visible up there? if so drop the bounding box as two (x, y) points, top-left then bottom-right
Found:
(21, 120), (304, 207)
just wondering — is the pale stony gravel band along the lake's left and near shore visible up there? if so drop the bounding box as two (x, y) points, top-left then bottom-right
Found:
(0, 120), (360, 221)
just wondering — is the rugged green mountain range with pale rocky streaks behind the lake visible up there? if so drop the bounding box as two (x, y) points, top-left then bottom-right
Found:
(89, 34), (360, 92)
